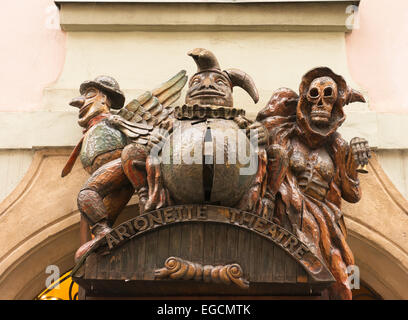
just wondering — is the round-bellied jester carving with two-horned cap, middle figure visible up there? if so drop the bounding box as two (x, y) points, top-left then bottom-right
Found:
(124, 48), (268, 211)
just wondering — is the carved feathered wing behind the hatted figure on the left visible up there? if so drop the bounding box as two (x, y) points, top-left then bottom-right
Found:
(109, 70), (187, 144)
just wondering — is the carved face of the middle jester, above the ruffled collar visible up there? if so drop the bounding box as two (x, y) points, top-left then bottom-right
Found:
(186, 71), (233, 108)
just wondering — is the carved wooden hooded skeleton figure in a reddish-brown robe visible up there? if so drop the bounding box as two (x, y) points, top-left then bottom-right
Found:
(257, 68), (370, 299)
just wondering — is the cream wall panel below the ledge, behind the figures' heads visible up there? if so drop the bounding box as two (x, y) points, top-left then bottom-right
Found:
(50, 32), (350, 115)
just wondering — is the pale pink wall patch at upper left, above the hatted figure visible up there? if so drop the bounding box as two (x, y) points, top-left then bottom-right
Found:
(0, 0), (65, 111)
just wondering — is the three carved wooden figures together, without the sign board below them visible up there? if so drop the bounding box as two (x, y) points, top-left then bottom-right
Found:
(63, 48), (370, 299)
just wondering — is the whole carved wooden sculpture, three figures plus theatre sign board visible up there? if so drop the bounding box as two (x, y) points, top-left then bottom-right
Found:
(67, 48), (370, 299)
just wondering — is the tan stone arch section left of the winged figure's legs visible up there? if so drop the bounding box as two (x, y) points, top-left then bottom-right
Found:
(0, 148), (83, 299)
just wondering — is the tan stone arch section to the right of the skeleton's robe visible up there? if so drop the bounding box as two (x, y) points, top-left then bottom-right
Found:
(343, 154), (408, 299)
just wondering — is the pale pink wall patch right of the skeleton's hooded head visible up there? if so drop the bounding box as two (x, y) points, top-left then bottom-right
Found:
(346, 0), (408, 113)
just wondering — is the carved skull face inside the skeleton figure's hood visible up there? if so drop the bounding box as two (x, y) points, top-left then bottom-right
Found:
(307, 77), (338, 127)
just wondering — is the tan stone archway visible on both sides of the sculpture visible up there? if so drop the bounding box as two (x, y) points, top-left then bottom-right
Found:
(0, 148), (408, 299)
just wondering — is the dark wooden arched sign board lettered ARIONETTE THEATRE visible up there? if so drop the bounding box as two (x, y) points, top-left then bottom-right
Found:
(73, 205), (334, 297)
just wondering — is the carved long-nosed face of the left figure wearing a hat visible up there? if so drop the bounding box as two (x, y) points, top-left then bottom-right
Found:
(69, 87), (111, 127)
